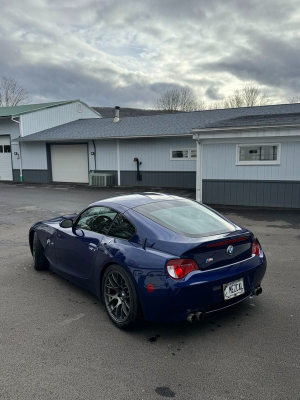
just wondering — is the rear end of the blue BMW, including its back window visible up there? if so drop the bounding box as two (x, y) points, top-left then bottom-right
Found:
(131, 200), (267, 321)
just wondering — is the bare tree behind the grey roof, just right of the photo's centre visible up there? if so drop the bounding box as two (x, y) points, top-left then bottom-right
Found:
(154, 87), (205, 111)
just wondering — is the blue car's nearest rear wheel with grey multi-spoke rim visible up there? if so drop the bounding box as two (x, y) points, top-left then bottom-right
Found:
(102, 264), (140, 329)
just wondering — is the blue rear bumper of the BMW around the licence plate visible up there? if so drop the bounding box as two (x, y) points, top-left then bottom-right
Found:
(142, 256), (267, 322)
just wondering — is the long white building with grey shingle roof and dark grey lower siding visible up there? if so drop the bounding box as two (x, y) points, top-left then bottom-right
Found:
(0, 100), (300, 208)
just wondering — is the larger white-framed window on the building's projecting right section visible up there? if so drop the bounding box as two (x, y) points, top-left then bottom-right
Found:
(236, 143), (280, 165)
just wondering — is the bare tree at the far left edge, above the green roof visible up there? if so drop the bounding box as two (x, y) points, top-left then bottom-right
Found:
(0, 76), (29, 107)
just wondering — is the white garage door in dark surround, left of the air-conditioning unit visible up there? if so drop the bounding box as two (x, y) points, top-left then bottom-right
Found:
(51, 144), (89, 183)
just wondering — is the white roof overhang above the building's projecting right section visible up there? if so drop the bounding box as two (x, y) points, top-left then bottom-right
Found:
(192, 125), (300, 141)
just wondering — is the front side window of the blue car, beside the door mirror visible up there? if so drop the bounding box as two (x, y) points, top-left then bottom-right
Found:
(77, 207), (117, 235)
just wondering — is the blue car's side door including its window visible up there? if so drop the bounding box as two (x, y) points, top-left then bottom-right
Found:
(55, 206), (117, 279)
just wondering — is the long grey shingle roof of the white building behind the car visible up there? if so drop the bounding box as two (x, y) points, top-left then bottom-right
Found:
(19, 103), (300, 142)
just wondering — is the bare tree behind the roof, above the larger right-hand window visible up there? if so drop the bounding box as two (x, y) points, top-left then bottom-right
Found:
(220, 86), (269, 108)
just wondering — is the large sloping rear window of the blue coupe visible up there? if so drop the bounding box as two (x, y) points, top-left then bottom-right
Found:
(134, 200), (236, 237)
